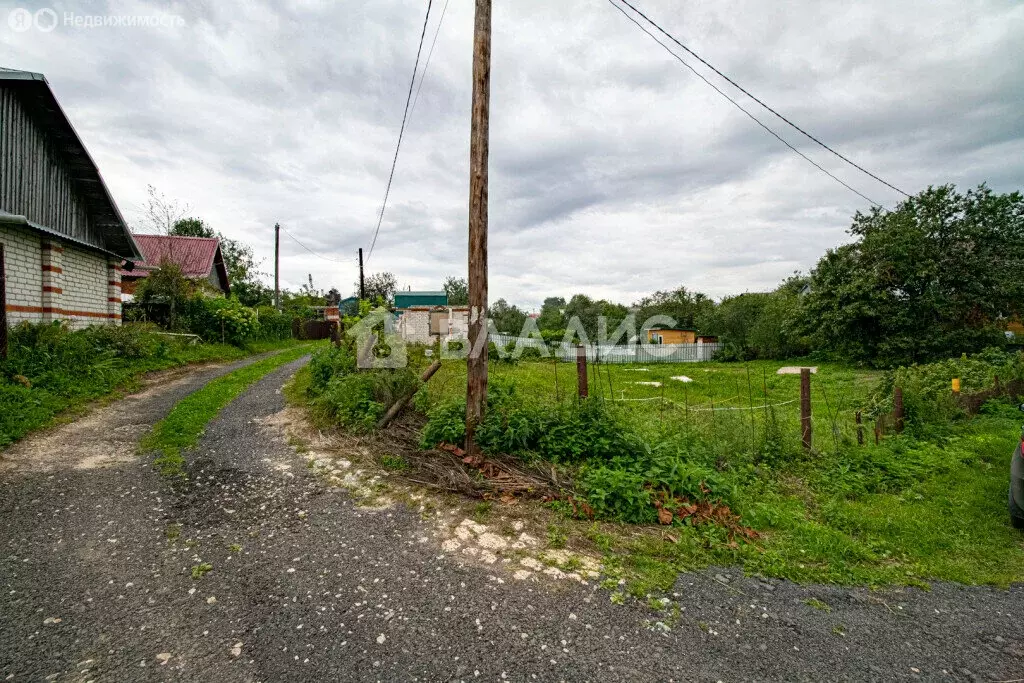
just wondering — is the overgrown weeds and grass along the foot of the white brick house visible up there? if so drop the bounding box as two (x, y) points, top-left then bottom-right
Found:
(0, 323), (299, 447)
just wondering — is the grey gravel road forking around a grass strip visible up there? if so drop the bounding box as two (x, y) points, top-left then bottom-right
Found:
(0, 360), (1024, 682)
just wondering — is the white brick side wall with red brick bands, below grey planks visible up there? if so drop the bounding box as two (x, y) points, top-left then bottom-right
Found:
(0, 225), (121, 329)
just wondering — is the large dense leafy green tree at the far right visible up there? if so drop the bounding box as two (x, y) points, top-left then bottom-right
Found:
(803, 184), (1024, 366)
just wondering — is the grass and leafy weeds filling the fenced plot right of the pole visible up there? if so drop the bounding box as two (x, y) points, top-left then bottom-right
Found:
(405, 351), (1024, 590)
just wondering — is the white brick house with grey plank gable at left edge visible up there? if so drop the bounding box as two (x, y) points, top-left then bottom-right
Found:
(0, 69), (140, 328)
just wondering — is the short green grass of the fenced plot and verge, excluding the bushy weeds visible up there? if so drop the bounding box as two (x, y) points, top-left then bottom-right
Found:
(418, 360), (1024, 596)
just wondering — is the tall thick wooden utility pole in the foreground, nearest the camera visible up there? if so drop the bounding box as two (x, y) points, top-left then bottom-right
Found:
(466, 0), (490, 456)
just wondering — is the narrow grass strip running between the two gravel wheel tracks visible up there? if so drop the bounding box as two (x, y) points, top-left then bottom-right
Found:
(140, 344), (310, 476)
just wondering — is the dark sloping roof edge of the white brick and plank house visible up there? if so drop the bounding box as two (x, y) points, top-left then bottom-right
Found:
(0, 67), (141, 259)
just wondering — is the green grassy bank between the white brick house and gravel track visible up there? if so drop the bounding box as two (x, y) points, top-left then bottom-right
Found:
(0, 333), (297, 451)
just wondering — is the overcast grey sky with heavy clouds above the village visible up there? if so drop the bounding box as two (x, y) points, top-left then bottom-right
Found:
(0, 0), (1024, 307)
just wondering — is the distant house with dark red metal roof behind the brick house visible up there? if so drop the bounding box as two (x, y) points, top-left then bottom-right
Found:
(121, 234), (231, 301)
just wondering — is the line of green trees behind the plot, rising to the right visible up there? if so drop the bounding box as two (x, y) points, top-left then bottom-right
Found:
(490, 184), (1024, 367)
